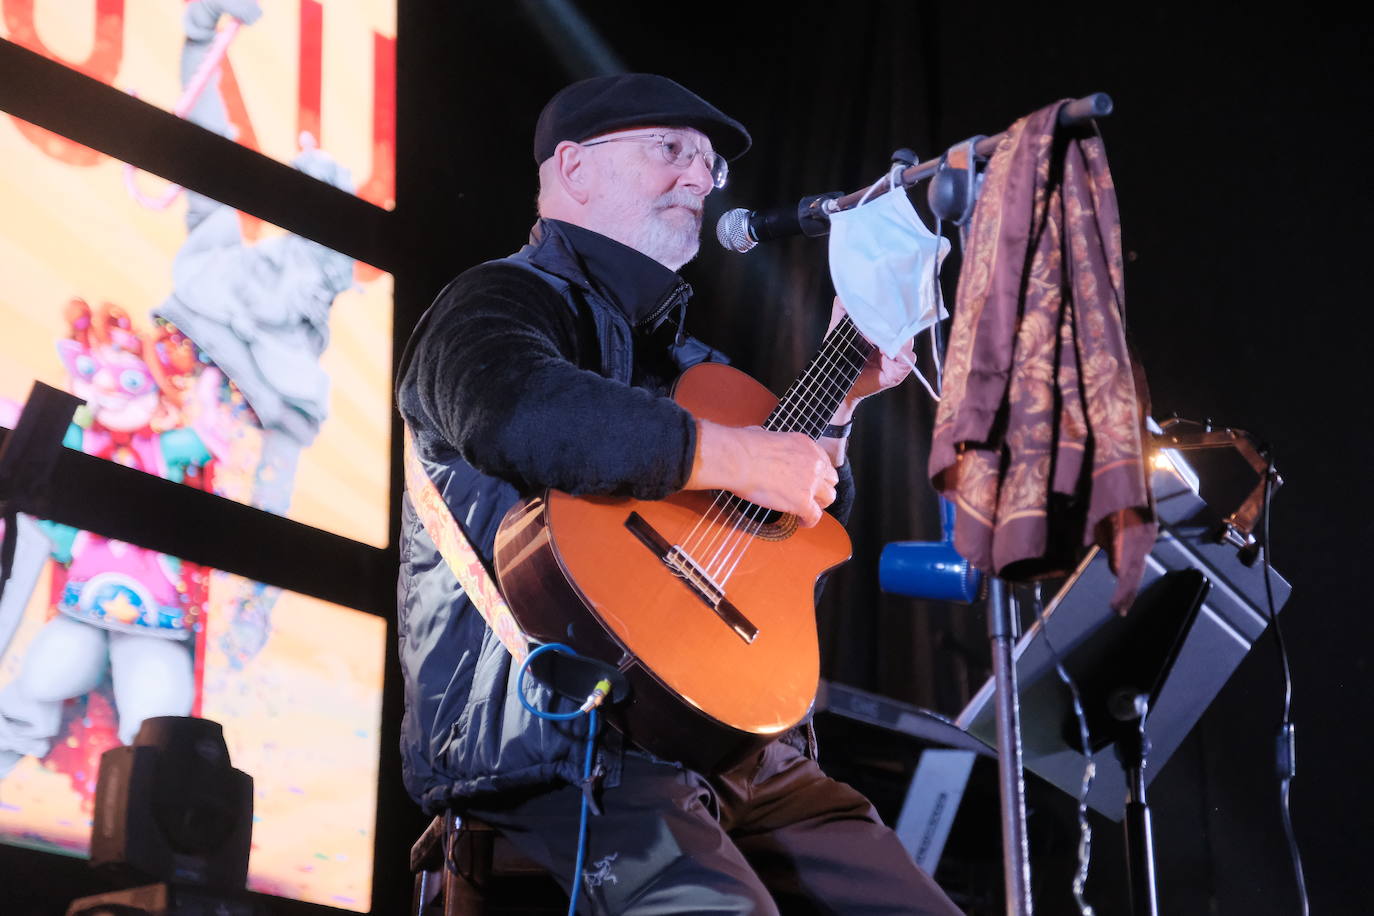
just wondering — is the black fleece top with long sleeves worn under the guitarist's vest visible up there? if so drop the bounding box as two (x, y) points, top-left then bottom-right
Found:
(398, 220), (852, 520)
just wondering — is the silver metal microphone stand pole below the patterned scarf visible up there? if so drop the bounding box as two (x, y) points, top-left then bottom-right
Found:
(988, 578), (1032, 916)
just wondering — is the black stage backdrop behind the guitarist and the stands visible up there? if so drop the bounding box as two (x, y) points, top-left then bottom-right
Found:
(0, 0), (1374, 915)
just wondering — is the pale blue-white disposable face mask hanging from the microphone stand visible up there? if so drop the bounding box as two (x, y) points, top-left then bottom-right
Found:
(830, 177), (949, 358)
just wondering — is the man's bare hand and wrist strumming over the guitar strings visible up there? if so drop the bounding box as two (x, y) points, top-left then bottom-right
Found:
(684, 420), (838, 527)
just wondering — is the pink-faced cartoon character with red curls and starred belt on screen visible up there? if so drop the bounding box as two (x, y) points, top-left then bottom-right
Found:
(0, 299), (213, 798)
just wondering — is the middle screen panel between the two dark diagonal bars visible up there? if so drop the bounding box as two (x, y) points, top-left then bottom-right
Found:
(0, 109), (392, 547)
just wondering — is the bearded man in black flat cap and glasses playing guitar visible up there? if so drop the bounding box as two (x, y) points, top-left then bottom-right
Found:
(397, 74), (958, 913)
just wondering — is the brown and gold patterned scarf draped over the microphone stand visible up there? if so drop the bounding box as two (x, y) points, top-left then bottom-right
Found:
(929, 102), (1156, 612)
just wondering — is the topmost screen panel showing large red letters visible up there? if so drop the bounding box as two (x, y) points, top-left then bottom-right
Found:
(0, 0), (396, 209)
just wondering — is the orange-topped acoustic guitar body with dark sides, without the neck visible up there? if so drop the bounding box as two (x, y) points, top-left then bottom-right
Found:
(496, 363), (851, 772)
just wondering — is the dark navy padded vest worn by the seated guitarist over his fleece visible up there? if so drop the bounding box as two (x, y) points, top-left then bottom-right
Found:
(397, 225), (724, 813)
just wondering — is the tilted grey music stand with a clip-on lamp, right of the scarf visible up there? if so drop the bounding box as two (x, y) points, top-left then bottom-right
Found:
(955, 449), (1292, 912)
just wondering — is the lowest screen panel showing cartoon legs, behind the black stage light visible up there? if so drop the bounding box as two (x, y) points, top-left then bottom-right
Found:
(0, 516), (386, 911)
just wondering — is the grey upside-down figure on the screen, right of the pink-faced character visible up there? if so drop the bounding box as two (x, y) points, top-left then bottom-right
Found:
(153, 0), (354, 667)
